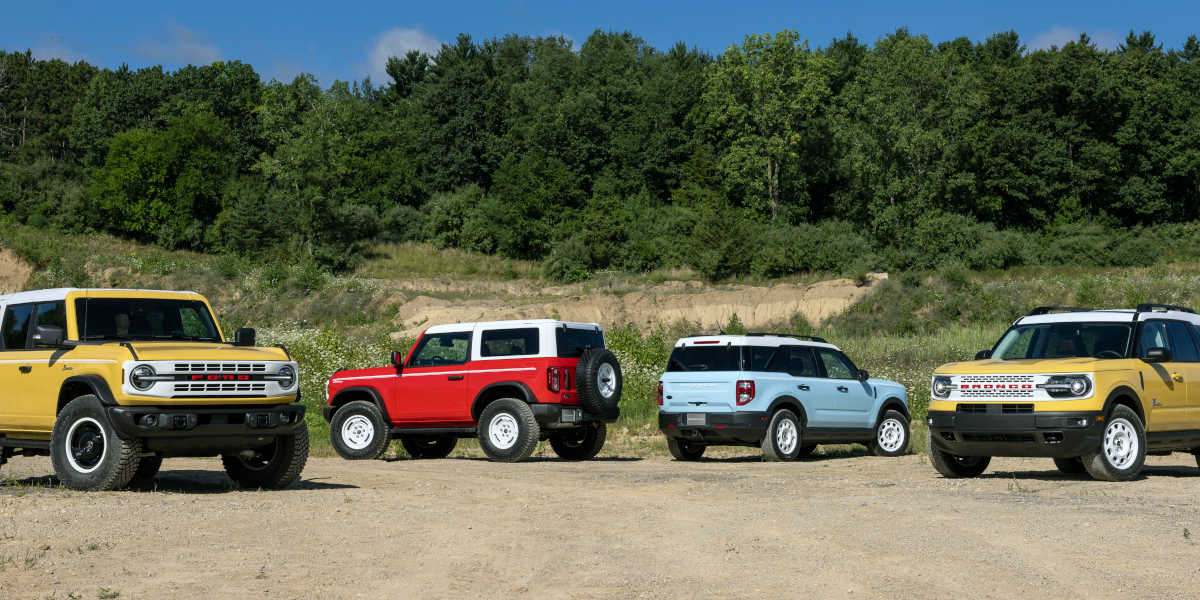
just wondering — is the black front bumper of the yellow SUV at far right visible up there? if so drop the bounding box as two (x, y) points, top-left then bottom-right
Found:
(925, 403), (1104, 458)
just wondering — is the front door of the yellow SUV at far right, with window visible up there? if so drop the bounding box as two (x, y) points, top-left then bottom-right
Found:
(1138, 319), (1188, 431)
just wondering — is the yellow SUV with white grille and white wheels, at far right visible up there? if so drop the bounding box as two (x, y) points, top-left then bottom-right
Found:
(926, 304), (1200, 481)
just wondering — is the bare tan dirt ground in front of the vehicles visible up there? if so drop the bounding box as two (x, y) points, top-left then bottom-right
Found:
(0, 452), (1200, 600)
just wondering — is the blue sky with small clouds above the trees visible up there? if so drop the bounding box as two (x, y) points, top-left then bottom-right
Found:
(9, 0), (1200, 84)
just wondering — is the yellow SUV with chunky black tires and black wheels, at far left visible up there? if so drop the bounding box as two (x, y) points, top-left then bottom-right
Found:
(0, 289), (308, 490)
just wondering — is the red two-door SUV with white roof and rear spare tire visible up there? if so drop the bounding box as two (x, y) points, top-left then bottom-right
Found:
(322, 319), (622, 462)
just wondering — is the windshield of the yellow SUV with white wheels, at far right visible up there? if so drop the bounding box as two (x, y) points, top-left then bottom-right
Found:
(991, 323), (1133, 360)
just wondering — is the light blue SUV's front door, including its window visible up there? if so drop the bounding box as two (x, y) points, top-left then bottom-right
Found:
(812, 348), (875, 428)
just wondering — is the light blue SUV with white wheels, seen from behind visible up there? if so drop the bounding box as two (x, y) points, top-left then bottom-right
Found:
(658, 334), (910, 461)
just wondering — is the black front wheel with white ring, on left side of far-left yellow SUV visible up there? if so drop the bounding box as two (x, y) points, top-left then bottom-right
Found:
(50, 395), (142, 491)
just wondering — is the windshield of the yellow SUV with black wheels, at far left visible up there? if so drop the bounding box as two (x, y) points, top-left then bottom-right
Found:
(76, 298), (221, 342)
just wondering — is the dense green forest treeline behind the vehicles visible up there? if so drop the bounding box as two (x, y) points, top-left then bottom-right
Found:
(0, 30), (1200, 280)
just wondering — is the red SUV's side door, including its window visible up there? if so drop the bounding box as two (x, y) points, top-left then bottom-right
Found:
(389, 330), (472, 427)
